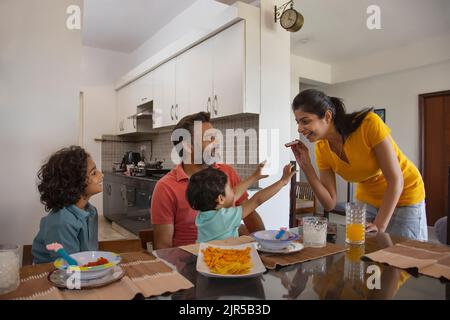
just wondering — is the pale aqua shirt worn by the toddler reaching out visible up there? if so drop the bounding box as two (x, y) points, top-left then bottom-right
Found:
(195, 207), (242, 242)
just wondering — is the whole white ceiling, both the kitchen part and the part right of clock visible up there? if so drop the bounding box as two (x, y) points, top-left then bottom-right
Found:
(83, 0), (450, 64)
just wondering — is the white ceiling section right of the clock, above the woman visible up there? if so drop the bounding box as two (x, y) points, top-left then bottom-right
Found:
(291, 0), (450, 64)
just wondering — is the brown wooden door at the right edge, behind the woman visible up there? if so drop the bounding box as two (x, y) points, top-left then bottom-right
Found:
(419, 91), (450, 226)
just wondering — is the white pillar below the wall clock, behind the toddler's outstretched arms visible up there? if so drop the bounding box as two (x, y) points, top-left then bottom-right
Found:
(257, 0), (291, 229)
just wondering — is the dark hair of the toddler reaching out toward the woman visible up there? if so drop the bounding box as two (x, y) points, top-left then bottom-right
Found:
(186, 167), (228, 211)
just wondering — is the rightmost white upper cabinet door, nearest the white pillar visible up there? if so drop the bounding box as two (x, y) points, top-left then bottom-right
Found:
(211, 21), (245, 117)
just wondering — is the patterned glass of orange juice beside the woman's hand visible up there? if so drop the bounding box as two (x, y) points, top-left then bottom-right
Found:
(345, 202), (366, 244)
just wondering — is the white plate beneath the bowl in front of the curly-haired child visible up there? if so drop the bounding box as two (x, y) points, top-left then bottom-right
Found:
(48, 266), (125, 289)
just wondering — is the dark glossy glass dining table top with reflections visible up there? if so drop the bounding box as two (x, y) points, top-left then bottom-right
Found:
(153, 225), (450, 300)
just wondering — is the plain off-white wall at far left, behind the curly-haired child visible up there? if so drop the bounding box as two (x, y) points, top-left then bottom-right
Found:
(0, 0), (82, 244)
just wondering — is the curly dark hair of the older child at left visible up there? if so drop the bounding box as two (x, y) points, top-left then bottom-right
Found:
(38, 146), (89, 211)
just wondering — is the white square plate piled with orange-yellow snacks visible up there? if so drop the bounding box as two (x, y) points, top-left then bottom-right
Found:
(197, 243), (266, 278)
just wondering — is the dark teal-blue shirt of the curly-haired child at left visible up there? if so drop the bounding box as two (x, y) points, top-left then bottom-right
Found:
(32, 203), (98, 263)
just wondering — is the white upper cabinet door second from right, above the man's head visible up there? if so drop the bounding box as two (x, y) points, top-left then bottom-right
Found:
(185, 39), (213, 114)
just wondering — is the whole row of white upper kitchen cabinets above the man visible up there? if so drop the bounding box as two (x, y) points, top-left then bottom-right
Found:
(118, 20), (260, 133)
